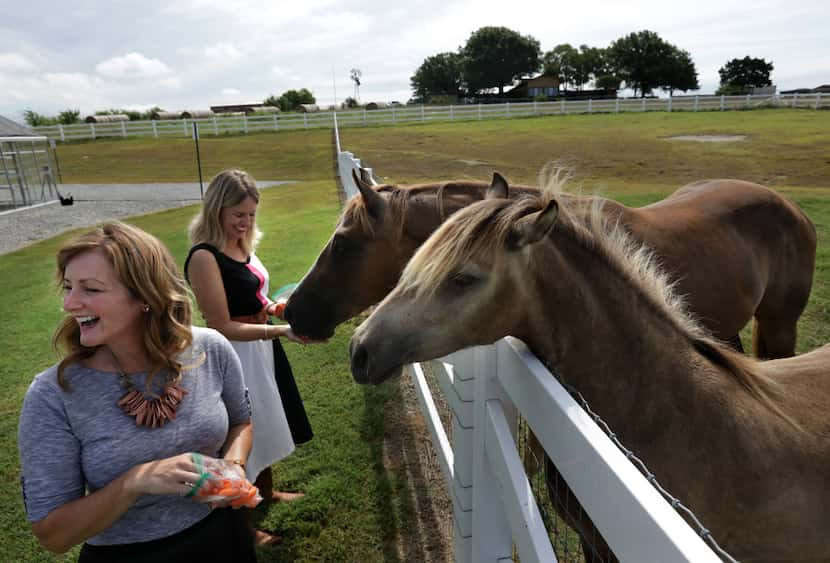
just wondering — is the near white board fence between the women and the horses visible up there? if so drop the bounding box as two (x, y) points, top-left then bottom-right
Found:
(335, 147), (721, 563)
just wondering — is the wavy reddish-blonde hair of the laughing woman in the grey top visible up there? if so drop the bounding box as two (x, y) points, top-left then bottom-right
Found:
(53, 222), (193, 391)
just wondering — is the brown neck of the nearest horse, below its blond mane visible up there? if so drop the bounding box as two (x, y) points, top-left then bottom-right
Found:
(519, 234), (712, 435)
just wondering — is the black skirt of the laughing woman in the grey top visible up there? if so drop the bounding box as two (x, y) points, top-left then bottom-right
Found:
(78, 508), (256, 563)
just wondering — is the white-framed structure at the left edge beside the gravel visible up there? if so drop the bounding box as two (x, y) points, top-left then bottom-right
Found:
(0, 116), (57, 209)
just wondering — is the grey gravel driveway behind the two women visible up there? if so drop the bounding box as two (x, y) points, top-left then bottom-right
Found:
(0, 182), (287, 254)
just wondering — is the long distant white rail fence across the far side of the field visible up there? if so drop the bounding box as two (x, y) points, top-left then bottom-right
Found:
(35, 93), (830, 141)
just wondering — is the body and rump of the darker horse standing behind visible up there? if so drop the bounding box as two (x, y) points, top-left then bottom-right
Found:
(624, 180), (816, 344)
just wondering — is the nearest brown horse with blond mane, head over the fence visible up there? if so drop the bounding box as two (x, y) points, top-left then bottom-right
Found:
(351, 184), (830, 561)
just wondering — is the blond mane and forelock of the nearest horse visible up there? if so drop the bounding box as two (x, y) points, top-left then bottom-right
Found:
(398, 169), (797, 426)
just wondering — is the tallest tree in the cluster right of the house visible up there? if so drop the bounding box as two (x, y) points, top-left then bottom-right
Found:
(608, 30), (677, 97)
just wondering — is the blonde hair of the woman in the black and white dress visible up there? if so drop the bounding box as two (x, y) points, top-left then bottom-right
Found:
(188, 169), (262, 254)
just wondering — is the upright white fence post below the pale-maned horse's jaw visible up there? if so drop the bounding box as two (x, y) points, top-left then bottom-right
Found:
(473, 346), (513, 563)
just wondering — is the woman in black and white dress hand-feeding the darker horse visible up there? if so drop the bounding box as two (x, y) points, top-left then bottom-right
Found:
(184, 170), (312, 545)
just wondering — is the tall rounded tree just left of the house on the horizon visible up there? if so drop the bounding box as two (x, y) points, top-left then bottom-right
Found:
(462, 27), (541, 94)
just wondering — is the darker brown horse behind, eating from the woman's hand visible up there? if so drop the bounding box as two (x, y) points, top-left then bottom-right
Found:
(285, 174), (816, 358)
